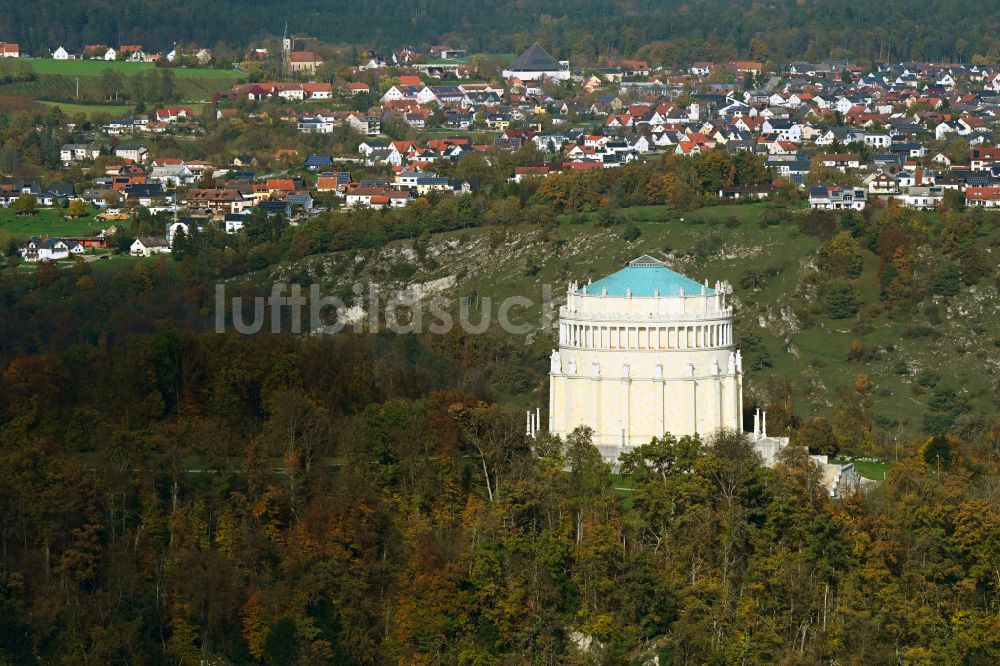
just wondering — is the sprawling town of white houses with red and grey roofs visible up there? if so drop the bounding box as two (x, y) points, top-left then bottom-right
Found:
(0, 35), (1000, 261)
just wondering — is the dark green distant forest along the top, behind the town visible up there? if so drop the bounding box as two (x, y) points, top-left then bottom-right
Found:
(0, 0), (1000, 64)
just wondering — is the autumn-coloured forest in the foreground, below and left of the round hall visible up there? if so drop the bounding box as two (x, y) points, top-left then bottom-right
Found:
(0, 260), (1000, 666)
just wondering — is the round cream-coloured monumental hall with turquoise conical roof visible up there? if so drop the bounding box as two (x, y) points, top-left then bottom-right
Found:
(549, 255), (743, 459)
